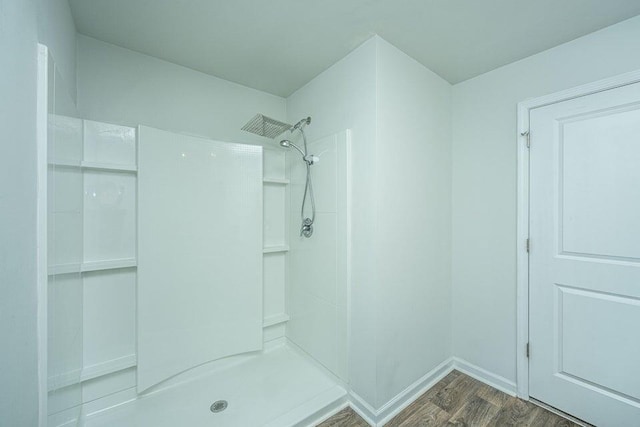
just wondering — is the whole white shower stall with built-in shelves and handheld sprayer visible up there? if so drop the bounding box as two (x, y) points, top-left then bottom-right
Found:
(39, 47), (350, 427)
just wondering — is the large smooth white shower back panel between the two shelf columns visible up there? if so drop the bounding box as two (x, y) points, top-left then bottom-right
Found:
(137, 127), (262, 392)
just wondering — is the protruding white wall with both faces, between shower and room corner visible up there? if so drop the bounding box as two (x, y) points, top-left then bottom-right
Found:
(287, 37), (451, 409)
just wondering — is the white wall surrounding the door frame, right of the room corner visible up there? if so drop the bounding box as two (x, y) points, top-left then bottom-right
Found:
(452, 17), (640, 381)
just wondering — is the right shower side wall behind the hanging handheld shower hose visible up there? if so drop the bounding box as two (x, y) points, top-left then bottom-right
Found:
(287, 131), (350, 381)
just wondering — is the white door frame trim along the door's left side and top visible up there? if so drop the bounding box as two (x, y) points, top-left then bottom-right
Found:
(516, 70), (640, 400)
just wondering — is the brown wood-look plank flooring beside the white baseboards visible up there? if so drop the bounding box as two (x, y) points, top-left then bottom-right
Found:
(318, 371), (578, 427)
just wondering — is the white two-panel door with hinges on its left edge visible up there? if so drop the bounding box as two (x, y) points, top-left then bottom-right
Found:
(529, 84), (640, 426)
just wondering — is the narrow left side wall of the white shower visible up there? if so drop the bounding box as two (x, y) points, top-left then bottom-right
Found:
(42, 55), (84, 422)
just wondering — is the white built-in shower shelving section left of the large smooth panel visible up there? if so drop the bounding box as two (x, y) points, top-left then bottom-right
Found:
(47, 114), (137, 425)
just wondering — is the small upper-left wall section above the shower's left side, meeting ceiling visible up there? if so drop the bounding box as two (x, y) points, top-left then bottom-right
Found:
(38, 0), (76, 101)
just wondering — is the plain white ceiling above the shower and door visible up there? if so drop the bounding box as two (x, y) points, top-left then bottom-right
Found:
(69, 0), (640, 96)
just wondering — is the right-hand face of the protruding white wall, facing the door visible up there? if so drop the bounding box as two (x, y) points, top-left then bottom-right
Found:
(375, 38), (451, 407)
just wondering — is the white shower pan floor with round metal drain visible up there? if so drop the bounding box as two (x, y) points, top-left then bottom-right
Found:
(84, 343), (347, 427)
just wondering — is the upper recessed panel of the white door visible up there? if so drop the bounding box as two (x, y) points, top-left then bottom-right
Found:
(559, 106), (640, 261)
